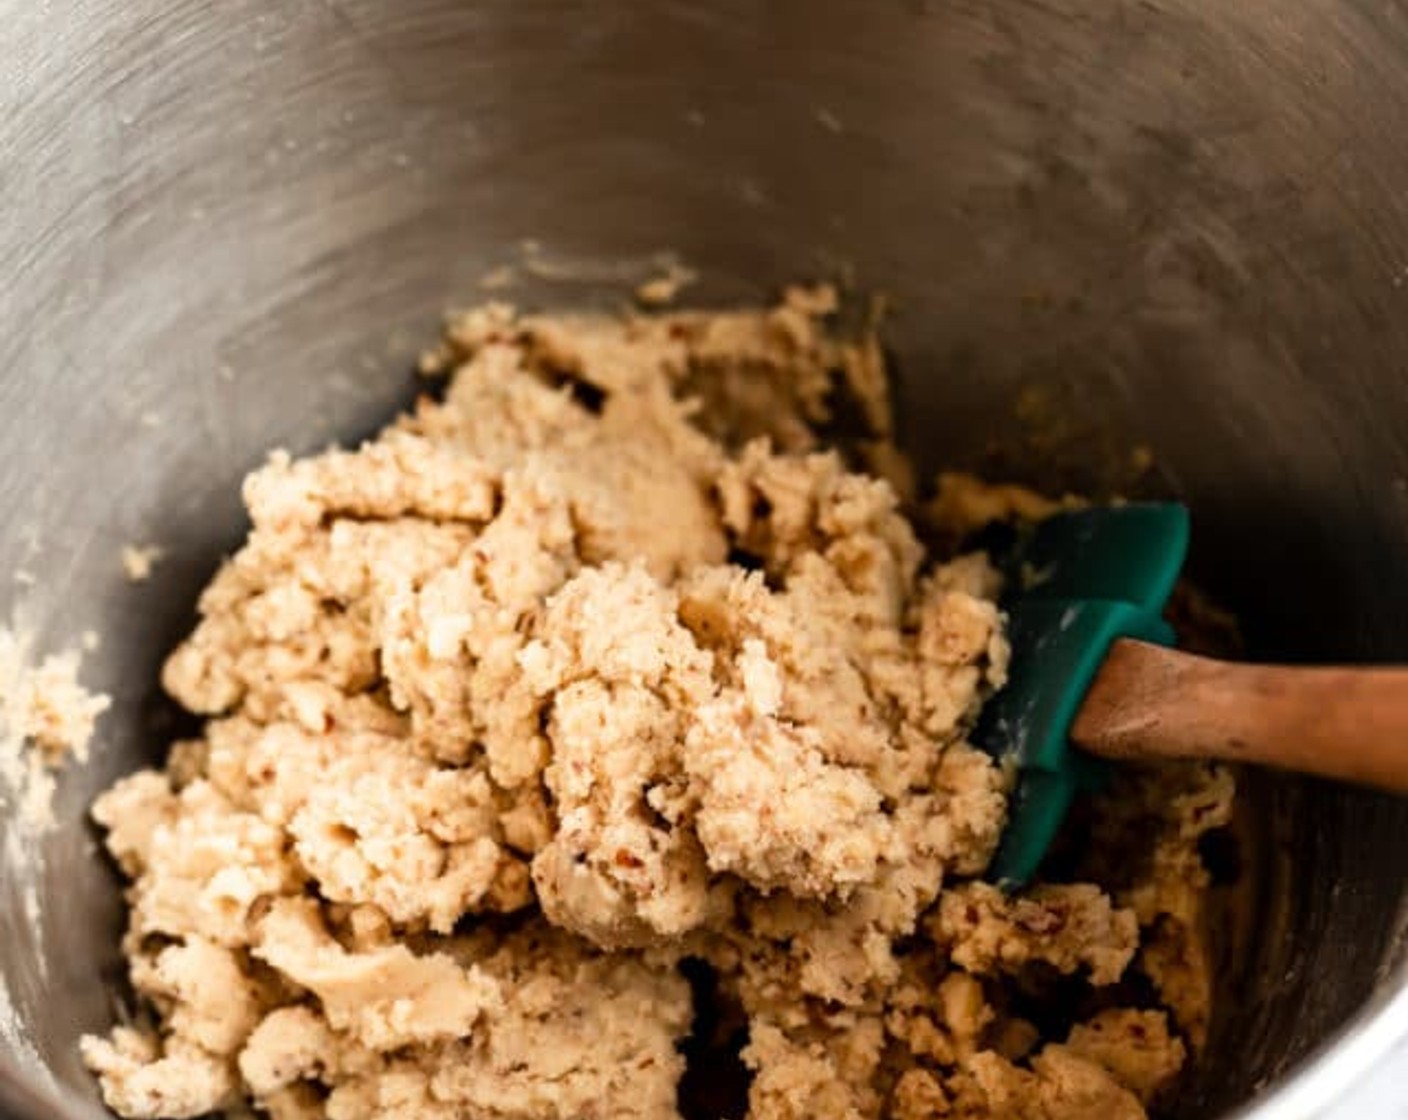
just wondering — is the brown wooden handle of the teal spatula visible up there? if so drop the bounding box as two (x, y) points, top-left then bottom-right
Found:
(1071, 638), (1408, 793)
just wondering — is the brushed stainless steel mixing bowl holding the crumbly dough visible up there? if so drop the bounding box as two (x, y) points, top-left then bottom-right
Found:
(0, 0), (1408, 1120)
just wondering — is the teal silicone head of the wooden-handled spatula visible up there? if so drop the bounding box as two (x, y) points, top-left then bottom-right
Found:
(974, 503), (1188, 888)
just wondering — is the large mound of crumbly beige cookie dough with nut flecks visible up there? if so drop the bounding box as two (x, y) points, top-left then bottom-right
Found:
(83, 289), (1232, 1120)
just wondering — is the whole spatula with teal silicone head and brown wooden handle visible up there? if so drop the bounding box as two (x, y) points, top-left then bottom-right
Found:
(974, 503), (1408, 888)
